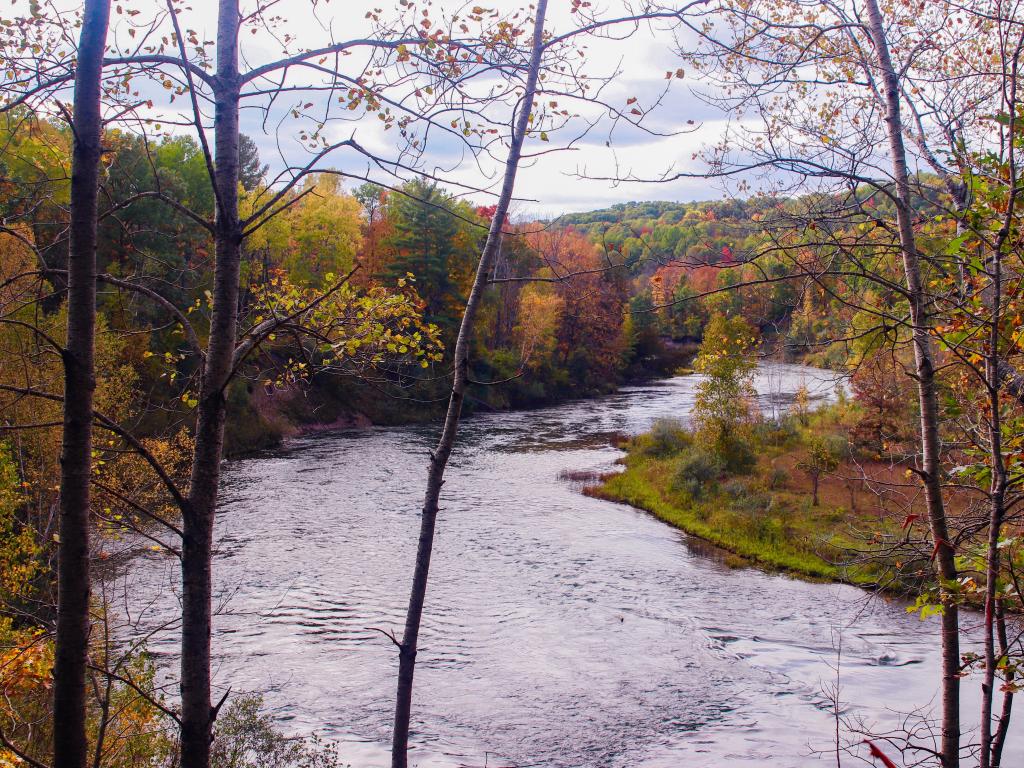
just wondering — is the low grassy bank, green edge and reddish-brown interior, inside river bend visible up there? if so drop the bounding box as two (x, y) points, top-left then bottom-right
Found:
(588, 408), (902, 586)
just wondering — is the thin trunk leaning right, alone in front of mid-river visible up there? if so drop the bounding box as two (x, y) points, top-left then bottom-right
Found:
(391, 0), (548, 768)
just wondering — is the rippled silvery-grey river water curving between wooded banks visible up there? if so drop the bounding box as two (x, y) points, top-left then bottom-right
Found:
(133, 366), (1024, 768)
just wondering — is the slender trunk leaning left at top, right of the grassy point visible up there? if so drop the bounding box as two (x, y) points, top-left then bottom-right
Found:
(865, 0), (961, 768)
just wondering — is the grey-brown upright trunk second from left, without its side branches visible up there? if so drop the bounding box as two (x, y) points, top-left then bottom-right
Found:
(181, 0), (242, 768)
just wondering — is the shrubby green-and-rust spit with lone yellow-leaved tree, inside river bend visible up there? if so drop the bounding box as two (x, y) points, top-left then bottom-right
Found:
(588, 315), (895, 585)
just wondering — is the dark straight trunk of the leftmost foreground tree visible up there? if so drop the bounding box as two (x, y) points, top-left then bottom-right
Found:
(53, 0), (111, 768)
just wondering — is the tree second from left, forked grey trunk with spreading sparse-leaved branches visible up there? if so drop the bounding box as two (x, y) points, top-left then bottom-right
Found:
(0, 0), (552, 768)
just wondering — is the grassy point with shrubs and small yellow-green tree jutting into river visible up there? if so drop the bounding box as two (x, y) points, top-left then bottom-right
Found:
(598, 315), (1021, 616)
